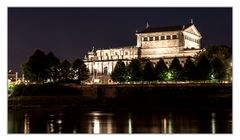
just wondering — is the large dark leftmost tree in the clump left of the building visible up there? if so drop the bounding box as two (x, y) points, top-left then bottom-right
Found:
(22, 49), (48, 83)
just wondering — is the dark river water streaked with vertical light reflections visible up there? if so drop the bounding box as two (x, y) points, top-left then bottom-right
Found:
(8, 109), (232, 134)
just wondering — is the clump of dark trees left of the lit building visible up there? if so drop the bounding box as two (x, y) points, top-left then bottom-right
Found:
(21, 49), (89, 84)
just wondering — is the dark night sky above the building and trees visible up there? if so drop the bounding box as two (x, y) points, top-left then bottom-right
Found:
(8, 7), (232, 72)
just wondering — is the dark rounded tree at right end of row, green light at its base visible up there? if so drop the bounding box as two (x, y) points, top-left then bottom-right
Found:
(210, 57), (226, 81)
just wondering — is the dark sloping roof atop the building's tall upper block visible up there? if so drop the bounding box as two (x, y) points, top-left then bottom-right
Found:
(137, 24), (193, 33)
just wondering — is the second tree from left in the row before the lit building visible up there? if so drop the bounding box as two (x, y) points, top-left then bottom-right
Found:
(127, 59), (143, 81)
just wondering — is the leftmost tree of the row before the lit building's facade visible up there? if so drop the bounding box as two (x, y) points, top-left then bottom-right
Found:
(111, 60), (126, 83)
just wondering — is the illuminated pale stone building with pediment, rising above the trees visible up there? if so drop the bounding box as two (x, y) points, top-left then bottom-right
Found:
(84, 22), (202, 83)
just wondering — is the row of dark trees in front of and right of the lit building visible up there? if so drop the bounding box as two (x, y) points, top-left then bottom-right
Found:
(111, 45), (232, 83)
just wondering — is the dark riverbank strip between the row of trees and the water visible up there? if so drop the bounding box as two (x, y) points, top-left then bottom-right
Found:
(8, 84), (232, 110)
